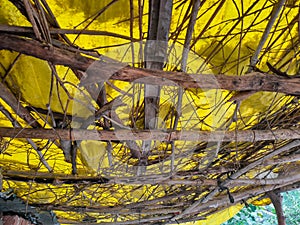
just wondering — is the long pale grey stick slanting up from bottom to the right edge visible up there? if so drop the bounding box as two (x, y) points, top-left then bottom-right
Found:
(172, 140), (300, 220)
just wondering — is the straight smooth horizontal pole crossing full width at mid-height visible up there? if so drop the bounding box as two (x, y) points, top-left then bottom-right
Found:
(0, 127), (300, 142)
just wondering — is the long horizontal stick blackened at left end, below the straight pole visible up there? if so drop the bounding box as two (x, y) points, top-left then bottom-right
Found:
(2, 170), (300, 187)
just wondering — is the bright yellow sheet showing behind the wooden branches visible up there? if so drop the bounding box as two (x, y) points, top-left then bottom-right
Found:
(0, 0), (299, 225)
